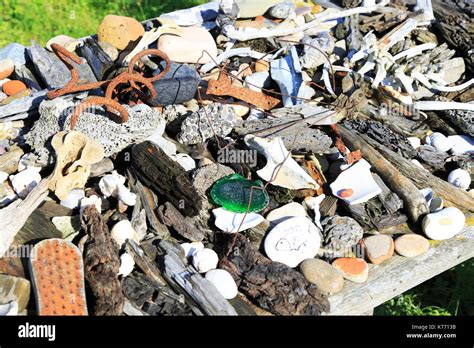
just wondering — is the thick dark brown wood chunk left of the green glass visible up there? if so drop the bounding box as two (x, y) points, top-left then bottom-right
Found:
(132, 141), (202, 216)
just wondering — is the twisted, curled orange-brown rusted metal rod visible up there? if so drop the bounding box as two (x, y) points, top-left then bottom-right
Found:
(47, 44), (171, 130)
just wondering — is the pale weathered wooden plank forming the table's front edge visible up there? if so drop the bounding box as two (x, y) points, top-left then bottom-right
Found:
(324, 226), (474, 315)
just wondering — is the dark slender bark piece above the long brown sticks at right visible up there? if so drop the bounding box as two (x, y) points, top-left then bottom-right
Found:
(343, 120), (416, 159)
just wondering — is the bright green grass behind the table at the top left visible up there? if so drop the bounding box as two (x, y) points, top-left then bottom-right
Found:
(0, 0), (206, 47)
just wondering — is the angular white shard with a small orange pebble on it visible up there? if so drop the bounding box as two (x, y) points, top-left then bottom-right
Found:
(329, 159), (382, 205)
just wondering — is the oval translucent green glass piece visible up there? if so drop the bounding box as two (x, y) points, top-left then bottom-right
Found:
(210, 174), (269, 213)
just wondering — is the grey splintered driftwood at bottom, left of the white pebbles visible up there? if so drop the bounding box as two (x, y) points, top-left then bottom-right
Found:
(158, 241), (237, 315)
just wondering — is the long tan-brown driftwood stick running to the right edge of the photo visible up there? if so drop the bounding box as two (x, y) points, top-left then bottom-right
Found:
(361, 135), (474, 211)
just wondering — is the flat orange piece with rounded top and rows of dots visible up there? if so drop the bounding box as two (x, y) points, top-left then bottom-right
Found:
(30, 238), (87, 315)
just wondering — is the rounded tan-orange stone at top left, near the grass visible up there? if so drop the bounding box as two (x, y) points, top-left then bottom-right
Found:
(97, 15), (145, 50)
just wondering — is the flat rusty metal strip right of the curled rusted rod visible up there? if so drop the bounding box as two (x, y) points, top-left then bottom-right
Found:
(207, 74), (280, 110)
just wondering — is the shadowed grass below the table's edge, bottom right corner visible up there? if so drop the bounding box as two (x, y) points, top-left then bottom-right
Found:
(374, 259), (474, 316)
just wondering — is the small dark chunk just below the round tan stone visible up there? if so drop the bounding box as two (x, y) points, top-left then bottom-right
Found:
(76, 38), (114, 81)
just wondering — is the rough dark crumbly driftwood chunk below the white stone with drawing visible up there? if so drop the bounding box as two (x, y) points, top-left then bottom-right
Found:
(220, 234), (328, 315)
